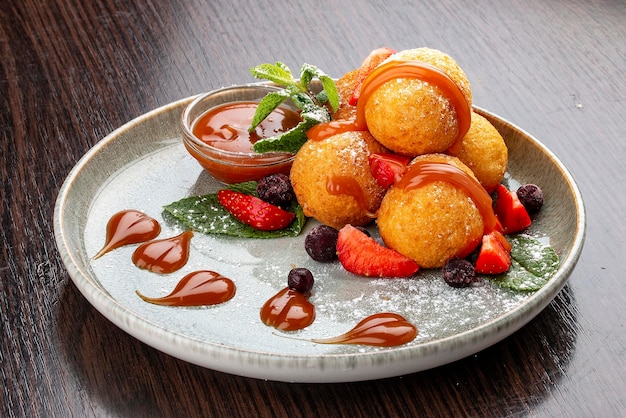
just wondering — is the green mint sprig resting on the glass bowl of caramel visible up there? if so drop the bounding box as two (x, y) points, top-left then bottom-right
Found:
(249, 61), (339, 154)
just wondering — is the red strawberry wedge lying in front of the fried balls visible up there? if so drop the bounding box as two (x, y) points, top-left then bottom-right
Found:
(337, 225), (419, 277)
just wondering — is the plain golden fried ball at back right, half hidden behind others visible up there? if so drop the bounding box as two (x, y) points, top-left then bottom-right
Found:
(447, 112), (509, 193)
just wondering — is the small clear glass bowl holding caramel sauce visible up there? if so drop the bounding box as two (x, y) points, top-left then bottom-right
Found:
(181, 85), (299, 184)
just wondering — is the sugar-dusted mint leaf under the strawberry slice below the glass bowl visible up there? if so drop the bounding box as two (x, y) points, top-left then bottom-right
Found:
(163, 182), (306, 238)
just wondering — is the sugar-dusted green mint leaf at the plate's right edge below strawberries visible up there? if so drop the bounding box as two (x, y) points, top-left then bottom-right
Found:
(489, 235), (559, 291)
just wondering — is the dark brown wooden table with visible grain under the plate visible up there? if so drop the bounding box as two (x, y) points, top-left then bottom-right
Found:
(0, 0), (626, 417)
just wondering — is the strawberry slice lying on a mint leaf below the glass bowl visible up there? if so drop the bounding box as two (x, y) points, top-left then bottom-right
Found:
(217, 190), (296, 231)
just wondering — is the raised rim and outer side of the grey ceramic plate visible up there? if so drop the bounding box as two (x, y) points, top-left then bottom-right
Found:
(54, 94), (586, 383)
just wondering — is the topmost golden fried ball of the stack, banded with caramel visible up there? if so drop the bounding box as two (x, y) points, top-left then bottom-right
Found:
(365, 48), (472, 157)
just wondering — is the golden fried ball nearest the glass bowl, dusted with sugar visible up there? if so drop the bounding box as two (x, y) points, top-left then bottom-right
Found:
(290, 132), (386, 229)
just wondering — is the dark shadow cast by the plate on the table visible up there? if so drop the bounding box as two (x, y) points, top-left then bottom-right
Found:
(56, 280), (578, 417)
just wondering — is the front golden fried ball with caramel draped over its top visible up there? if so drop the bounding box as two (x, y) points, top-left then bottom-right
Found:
(377, 154), (484, 268)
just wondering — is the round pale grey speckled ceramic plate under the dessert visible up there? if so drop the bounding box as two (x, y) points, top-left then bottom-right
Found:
(54, 92), (585, 382)
